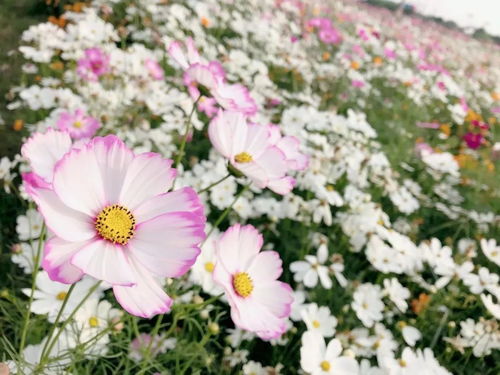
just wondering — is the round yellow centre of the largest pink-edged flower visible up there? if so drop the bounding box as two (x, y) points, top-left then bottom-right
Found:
(95, 204), (135, 245)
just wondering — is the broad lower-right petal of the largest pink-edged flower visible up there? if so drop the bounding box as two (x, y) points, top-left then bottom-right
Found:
(129, 212), (205, 277)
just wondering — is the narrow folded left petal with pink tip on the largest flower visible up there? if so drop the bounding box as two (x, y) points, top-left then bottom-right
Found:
(27, 186), (95, 241)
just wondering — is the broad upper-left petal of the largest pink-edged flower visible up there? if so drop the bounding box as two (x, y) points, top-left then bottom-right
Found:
(53, 144), (106, 217)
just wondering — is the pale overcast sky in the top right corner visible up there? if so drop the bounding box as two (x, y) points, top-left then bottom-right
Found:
(391, 0), (500, 36)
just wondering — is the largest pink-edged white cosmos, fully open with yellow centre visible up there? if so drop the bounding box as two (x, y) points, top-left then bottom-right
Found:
(23, 135), (205, 317)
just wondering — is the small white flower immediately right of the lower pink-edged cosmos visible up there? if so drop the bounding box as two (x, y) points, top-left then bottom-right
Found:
(290, 244), (332, 289)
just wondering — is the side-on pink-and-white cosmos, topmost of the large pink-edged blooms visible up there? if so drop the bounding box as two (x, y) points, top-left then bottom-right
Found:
(168, 38), (258, 117)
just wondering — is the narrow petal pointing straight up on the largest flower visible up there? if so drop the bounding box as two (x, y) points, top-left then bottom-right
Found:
(92, 135), (134, 204)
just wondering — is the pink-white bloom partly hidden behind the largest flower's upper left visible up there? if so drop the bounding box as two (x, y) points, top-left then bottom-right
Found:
(21, 128), (71, 187)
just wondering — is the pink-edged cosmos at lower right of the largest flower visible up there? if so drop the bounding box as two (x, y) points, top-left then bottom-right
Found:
(213, 224), (293, 340)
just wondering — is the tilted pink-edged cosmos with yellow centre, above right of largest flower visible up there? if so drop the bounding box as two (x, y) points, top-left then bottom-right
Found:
(208, 111), (295, 195)
